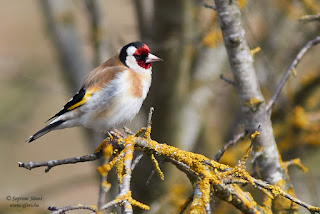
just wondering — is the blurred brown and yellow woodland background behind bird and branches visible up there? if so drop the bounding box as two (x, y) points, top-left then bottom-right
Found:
(0, 0), (320, 214)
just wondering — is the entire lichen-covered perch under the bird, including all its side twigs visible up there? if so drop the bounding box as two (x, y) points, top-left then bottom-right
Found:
(21, 112), (320, 214)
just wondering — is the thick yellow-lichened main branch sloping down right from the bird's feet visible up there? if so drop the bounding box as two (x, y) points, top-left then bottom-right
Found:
(106, 131), (260, 213)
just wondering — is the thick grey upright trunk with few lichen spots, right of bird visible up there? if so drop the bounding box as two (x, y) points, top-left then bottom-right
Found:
(215, 0), (297, 212)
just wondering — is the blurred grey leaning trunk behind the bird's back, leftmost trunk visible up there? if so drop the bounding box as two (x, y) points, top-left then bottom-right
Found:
(40, 0), (89, 93)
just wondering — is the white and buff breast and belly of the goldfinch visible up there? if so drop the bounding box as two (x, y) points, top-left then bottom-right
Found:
(86, 70), (151, 131)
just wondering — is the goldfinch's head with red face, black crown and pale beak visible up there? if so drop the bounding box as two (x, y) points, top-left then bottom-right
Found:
(119, 42), (162, 71)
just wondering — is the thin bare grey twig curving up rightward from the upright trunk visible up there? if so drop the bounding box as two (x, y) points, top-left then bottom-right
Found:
(266, 36), (320, 114)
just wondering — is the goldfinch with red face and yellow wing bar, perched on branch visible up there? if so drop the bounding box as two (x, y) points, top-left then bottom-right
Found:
(26, 41), (162, 143)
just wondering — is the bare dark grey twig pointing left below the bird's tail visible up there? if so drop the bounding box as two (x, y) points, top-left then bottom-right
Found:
(18, 152), (102, 172)
